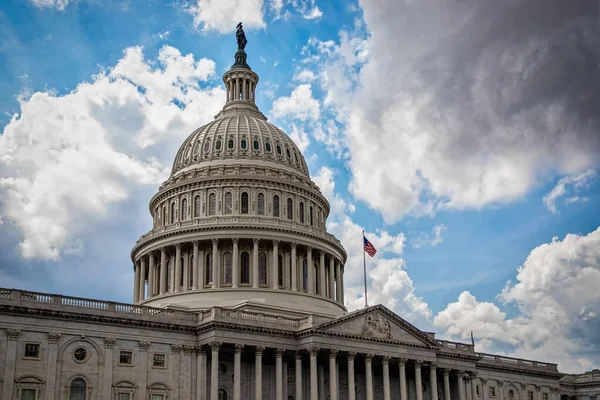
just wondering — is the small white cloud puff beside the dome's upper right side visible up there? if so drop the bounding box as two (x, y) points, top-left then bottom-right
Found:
(271, 84), (320, 121)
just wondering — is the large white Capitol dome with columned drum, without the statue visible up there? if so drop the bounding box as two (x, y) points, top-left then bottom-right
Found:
(131, 39), (347, 317)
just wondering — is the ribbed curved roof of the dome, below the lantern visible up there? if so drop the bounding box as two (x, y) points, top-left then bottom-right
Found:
(171, 112), (310, 177)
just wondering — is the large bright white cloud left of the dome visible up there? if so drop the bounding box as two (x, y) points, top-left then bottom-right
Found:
(0, 46), (224, 260)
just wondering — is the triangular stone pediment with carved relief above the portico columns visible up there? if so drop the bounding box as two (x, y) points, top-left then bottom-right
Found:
(316, 305), (438, 347)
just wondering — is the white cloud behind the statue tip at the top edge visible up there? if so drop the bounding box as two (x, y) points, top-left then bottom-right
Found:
(188, 0), (266, 33)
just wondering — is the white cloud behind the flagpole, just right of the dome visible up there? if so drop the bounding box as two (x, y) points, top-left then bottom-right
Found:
(312, 167), (431, 327)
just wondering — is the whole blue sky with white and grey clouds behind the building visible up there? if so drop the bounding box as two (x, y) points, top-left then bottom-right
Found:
(0, 0), (600, 371)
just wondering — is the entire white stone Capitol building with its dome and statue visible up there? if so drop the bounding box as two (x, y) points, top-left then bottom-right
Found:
(0, 29), (600, 400)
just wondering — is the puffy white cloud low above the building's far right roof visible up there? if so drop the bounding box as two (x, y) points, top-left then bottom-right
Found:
(434, 228), (600, 372)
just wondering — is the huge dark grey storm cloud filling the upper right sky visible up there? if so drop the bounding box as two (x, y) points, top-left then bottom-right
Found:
(304, 0), (600, 223)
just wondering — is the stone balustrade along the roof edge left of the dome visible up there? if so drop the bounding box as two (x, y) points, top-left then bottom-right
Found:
(0, 288), (197, 325)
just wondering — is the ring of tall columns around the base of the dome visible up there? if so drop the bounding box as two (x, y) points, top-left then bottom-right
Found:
(133, 238), (344, 304)
